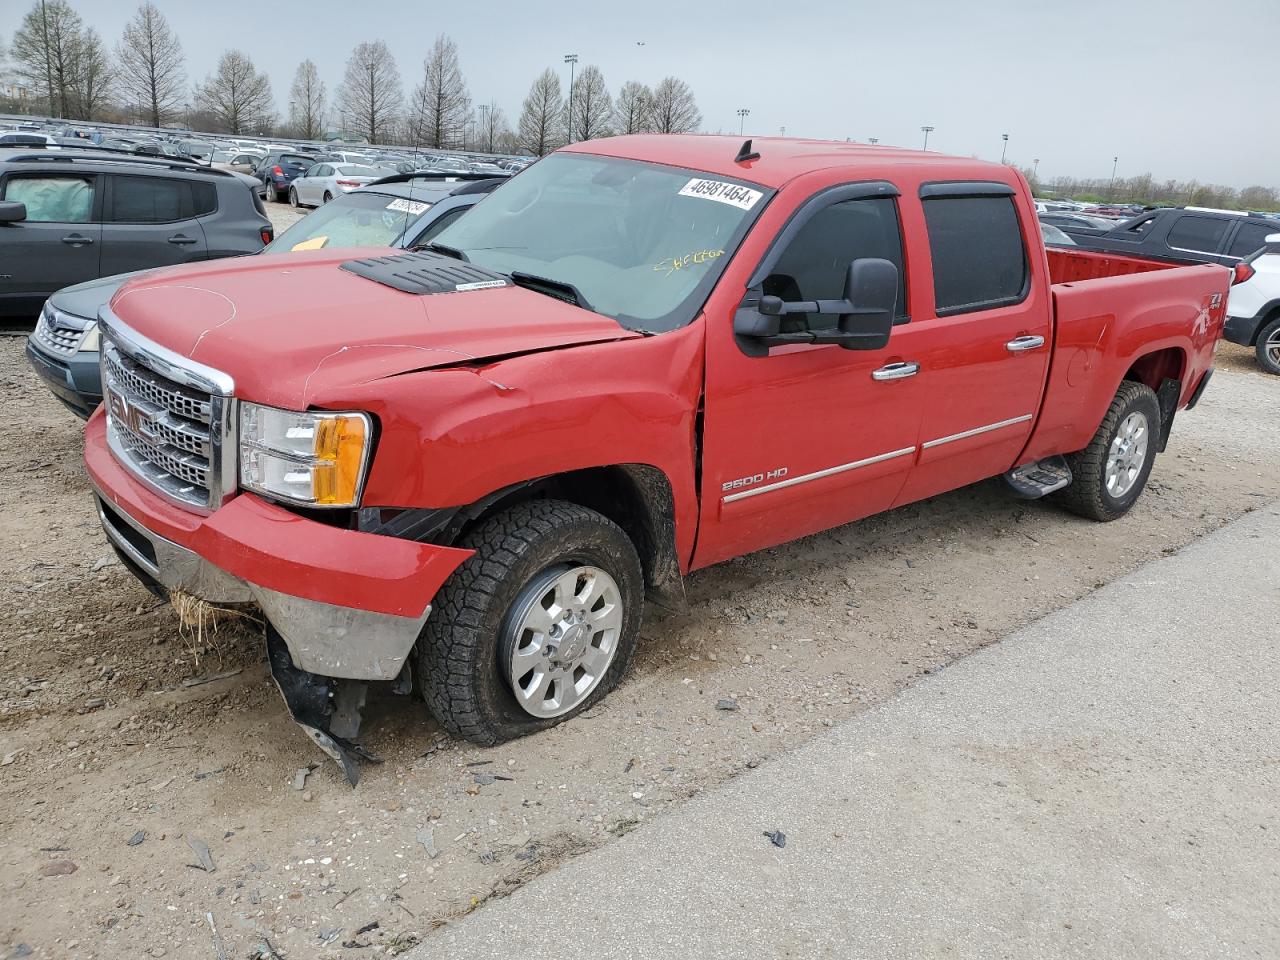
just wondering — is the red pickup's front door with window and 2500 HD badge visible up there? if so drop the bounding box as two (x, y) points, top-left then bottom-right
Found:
(694, 183), (924, 567)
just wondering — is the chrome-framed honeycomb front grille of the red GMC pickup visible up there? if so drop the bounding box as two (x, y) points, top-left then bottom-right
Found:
(101, 321), (233, 511)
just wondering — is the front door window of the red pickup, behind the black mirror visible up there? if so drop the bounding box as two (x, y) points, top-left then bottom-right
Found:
(763, 197), (906, 332)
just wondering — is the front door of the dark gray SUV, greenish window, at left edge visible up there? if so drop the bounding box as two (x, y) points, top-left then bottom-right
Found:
(0, 172), (102, 307)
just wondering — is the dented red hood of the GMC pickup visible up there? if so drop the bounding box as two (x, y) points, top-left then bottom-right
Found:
(103, 247), (641, 410)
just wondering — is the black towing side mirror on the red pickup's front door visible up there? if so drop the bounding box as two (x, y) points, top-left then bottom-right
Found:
(733, 257), (897, 357)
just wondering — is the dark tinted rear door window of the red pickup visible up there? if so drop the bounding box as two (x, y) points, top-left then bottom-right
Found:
(924, 197), (1027, 316)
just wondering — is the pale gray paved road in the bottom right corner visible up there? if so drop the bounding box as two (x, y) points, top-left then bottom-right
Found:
(412, 506), (1280, 960)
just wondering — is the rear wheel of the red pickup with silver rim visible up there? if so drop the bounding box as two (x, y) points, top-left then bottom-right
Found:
(1053, 380), (1161, 522)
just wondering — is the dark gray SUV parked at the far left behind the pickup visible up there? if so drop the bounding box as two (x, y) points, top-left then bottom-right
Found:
(0, 150), (274, 316)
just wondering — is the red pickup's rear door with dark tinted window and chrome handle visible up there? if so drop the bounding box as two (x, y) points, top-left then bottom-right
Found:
(896, 182), (1052, 503)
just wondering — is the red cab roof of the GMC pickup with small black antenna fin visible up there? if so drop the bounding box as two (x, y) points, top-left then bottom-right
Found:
(562, 133), (1010, 188)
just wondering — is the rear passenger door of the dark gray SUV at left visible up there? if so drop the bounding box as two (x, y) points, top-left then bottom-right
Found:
(102, 174), (207, 276)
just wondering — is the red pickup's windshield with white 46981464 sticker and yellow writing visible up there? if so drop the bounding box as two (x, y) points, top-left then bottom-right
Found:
(435, 154), (769, 333)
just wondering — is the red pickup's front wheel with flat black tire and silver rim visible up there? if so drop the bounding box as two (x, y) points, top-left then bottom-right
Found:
(416, 500), (644, 745)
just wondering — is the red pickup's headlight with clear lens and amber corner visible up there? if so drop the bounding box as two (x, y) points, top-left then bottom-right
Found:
(239, 402), (372, 507)
